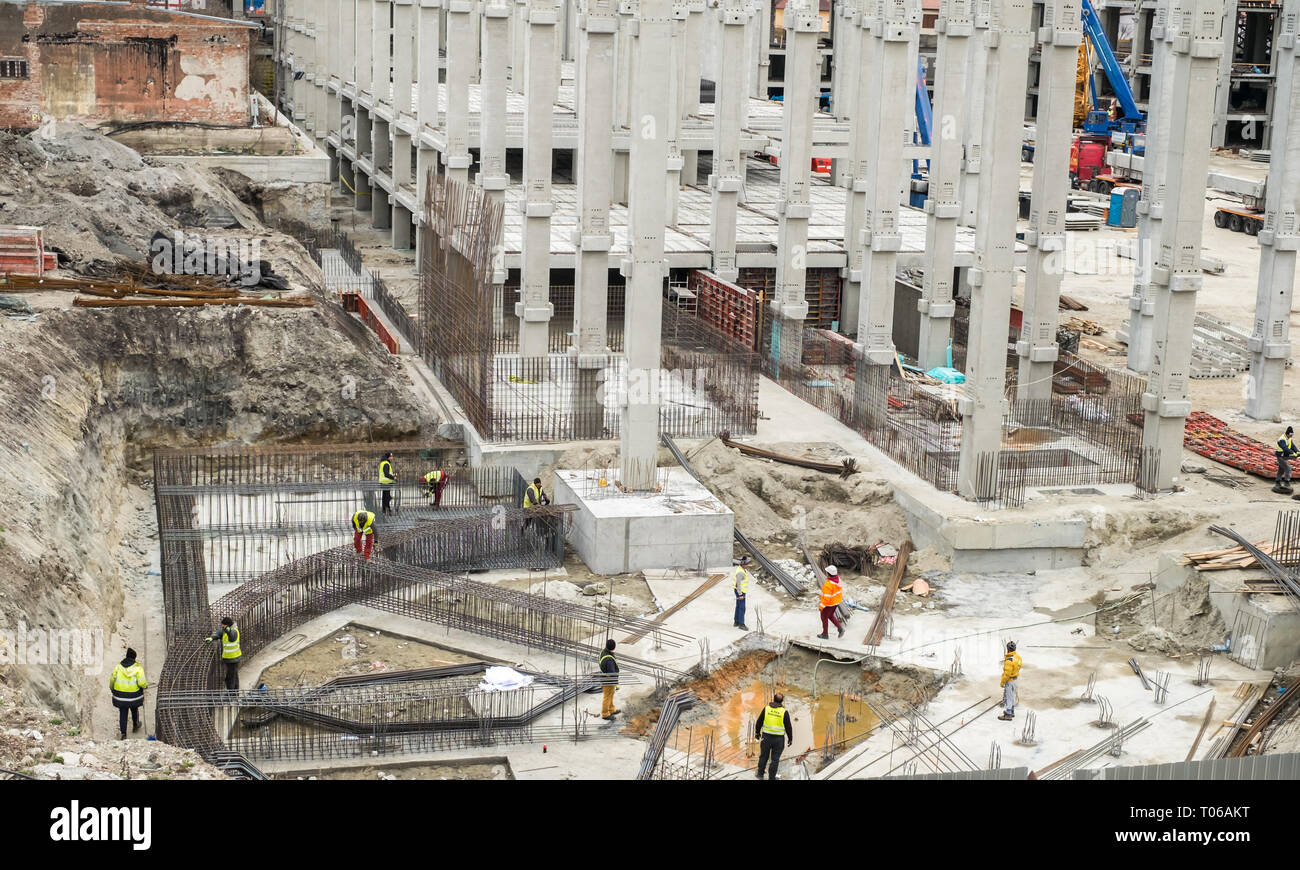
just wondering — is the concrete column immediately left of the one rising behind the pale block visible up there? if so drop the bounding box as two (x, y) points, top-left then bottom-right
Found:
(569, 0), (619, 438)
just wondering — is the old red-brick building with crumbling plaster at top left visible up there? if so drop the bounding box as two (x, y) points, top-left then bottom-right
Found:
(0, 0), (260, 130)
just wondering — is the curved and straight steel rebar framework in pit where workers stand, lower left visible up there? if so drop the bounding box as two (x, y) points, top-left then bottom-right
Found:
(155, 443), (690, 759)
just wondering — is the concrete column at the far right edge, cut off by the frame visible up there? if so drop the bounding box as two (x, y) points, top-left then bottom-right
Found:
(1245, 0), (1300, 421)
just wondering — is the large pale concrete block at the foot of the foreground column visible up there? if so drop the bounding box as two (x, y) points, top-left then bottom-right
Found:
(555, 468), (735, 573)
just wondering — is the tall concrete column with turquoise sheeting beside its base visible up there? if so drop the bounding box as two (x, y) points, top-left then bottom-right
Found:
(917, 0), (975, 371)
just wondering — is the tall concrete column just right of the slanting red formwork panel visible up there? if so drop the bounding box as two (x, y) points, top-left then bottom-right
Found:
(771, 0), (822, 365)
